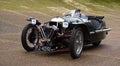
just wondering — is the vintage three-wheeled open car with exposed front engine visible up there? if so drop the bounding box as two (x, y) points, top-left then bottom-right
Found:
(21, 9), (110, 59)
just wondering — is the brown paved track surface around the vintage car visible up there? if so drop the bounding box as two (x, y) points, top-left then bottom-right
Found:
(0, 10), (120, 66)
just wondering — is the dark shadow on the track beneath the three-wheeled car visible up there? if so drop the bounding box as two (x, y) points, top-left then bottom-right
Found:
(21, 44), (109, 61)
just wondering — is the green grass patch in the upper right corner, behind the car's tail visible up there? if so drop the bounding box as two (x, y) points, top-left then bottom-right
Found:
(75, 0), (120, 11)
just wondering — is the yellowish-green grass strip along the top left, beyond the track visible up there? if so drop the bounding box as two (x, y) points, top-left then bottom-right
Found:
(0, 0), (73, 11)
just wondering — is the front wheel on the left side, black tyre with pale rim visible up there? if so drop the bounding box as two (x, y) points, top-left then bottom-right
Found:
(21, 24), (39, 51)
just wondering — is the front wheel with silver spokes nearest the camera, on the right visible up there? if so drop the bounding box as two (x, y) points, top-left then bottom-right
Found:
(70, 28), (84, 59)
